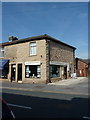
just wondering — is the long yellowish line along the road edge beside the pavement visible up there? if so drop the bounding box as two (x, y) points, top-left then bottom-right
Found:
(0, 87), (90, 96)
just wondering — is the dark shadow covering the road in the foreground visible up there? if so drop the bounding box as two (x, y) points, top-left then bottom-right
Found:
(2, 93), (90, 119)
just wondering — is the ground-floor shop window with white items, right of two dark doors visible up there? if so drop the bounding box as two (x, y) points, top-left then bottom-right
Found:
(25, 65), (41, 78)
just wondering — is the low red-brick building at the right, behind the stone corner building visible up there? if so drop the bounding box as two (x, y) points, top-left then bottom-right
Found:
(76, 58), (90, 77)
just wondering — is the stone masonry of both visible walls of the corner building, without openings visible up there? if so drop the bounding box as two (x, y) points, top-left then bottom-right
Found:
(1, 36), (75, 83)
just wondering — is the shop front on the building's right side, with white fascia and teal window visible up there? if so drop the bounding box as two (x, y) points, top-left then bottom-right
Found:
(50, 61), (73, 81)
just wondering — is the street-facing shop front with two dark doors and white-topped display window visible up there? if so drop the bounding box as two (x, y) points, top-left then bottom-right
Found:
(9, 61), (41, 82)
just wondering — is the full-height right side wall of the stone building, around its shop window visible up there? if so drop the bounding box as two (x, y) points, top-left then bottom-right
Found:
(50, 41), (75, 81)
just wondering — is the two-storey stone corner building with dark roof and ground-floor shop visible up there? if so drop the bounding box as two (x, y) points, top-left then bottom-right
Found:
(0, 34), (76, 83)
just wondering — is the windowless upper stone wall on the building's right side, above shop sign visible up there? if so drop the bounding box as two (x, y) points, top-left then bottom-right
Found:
(50, 41), (75, 65)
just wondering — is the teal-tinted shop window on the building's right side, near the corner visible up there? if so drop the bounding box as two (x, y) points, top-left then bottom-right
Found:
(50, 65), (60, 78)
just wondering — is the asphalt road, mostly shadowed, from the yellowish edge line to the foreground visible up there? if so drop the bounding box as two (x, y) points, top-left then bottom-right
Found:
(2, 89), (89, 119)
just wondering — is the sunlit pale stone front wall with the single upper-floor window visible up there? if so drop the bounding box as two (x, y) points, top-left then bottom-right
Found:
(4, 39), (47, 83)
